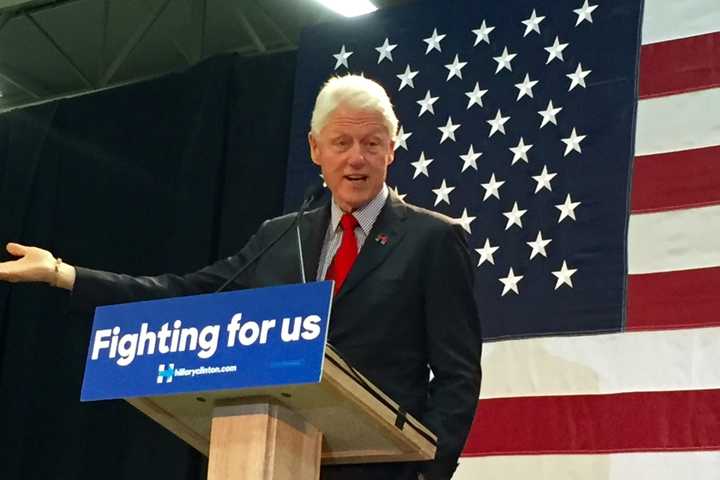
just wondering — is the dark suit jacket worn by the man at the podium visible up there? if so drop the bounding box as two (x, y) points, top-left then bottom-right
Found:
(73, 192), (481, 478)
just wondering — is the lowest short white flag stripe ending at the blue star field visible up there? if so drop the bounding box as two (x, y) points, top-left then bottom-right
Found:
(628, 205), (720, 274)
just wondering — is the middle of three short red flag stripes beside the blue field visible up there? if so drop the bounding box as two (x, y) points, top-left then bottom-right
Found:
(630, 146), (720, 213)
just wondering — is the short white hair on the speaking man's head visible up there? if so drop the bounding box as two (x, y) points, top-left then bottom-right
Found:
(310, 74), (398, 141)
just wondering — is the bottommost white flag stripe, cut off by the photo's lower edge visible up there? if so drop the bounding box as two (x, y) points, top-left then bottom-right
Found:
(453, 452), (720, 480)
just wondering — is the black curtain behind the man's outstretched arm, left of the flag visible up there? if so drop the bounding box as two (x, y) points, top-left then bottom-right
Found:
(0, 52), (295, 480)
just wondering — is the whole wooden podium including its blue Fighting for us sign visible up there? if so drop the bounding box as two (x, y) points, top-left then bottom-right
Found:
(81, 282), (436, 480)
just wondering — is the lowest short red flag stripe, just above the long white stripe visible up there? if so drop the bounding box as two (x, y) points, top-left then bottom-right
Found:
(626, 267), (720, 334)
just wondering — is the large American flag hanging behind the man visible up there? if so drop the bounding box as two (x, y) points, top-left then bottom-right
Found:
(286, 0), (720, 478)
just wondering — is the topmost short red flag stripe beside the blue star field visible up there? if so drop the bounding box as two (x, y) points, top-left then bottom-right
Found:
(640, 32), (720, 98)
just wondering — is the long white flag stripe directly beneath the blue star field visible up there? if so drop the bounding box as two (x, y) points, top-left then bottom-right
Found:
(480, 328), (720, 399)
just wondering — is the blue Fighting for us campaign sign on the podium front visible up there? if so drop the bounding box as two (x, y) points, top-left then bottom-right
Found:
(80, 282), (332, 401)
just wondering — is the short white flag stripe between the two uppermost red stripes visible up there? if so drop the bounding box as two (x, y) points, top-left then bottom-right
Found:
(635, 87), (720, 155)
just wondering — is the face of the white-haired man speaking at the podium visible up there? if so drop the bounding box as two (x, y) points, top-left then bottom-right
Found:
(308, 106), (394, 212)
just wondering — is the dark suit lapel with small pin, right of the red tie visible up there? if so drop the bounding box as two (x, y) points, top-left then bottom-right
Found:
(336, 190), (406, 300)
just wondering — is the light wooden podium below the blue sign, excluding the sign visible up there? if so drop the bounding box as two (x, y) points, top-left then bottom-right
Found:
(127, 348), (436, 480)
